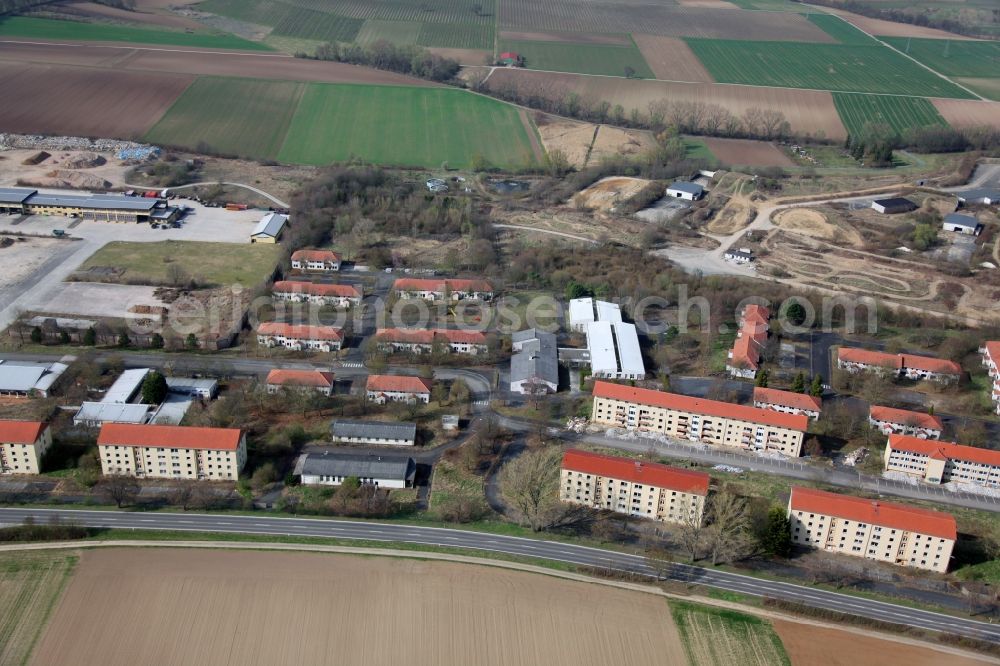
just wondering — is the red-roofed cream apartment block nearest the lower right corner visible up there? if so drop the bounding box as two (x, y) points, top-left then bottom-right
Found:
(788, 486), (957, 573)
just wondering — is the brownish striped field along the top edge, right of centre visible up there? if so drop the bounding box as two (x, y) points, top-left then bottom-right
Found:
(500, 0), (835, 44)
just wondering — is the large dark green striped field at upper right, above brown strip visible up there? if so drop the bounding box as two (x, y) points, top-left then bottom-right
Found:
(685, 38), (972, 99)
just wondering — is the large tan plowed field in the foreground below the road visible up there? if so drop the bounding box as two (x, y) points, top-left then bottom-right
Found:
(33, 548), (687, 666)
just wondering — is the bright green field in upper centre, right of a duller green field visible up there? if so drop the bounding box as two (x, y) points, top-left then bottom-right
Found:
(278, 83), (537, 168)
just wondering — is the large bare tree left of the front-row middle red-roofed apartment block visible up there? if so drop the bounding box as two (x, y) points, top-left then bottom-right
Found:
(500, 446), (566, 532)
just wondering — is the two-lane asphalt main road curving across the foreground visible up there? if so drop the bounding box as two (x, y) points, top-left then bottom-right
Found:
(0, 508), (1000, 644)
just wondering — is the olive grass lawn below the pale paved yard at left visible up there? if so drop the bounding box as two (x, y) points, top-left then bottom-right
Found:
(83, 241), (281, 286)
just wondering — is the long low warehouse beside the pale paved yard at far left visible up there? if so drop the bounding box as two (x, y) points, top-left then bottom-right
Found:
(0, 187), (180, 223)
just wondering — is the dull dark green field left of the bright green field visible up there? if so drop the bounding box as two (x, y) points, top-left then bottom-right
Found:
(145, 76), (305, 159)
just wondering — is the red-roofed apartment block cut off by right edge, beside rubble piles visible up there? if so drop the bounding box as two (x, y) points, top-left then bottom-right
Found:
(882, 435), (1000, 488)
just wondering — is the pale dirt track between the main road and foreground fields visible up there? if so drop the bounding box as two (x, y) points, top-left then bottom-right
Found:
(0, 540), (1000, 664)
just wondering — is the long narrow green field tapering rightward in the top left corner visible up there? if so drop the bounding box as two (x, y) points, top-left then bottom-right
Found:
(0, 16), (272, 51)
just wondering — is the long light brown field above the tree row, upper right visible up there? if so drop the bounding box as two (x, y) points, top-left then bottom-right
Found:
(489, 68), (847, 140)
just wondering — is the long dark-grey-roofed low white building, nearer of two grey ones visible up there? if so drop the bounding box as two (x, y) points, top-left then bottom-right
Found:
(294, 452), (417, 488)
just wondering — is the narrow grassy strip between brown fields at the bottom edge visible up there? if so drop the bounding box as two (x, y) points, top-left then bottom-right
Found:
(669, 600), (791, 666)
